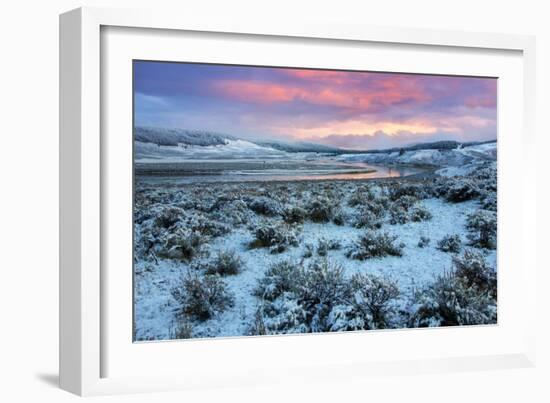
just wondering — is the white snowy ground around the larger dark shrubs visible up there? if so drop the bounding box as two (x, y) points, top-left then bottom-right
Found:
(134, 166), (496, 340)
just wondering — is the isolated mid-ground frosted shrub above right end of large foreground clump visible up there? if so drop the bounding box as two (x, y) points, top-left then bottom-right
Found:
(346, 231), (403, 260)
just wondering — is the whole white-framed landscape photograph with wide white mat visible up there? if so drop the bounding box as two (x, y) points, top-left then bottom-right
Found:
(60, 8), (536, 395)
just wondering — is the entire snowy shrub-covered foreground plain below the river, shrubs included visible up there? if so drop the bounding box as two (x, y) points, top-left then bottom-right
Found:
(134, 161), (496, 341)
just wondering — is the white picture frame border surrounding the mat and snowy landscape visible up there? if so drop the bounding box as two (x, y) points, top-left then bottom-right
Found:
(60, 8), (537, 395)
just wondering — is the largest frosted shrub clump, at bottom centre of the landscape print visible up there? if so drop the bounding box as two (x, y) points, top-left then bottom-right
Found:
(252, 259), (406, 334)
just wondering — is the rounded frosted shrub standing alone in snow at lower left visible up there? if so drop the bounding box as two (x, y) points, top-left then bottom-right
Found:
(172, 274), (233, 320)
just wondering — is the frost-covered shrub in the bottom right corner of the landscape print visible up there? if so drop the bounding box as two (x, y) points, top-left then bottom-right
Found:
(410, 274), (497, 327)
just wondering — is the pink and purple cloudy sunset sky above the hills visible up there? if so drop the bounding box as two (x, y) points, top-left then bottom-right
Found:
(134, 61), (497, 150)
